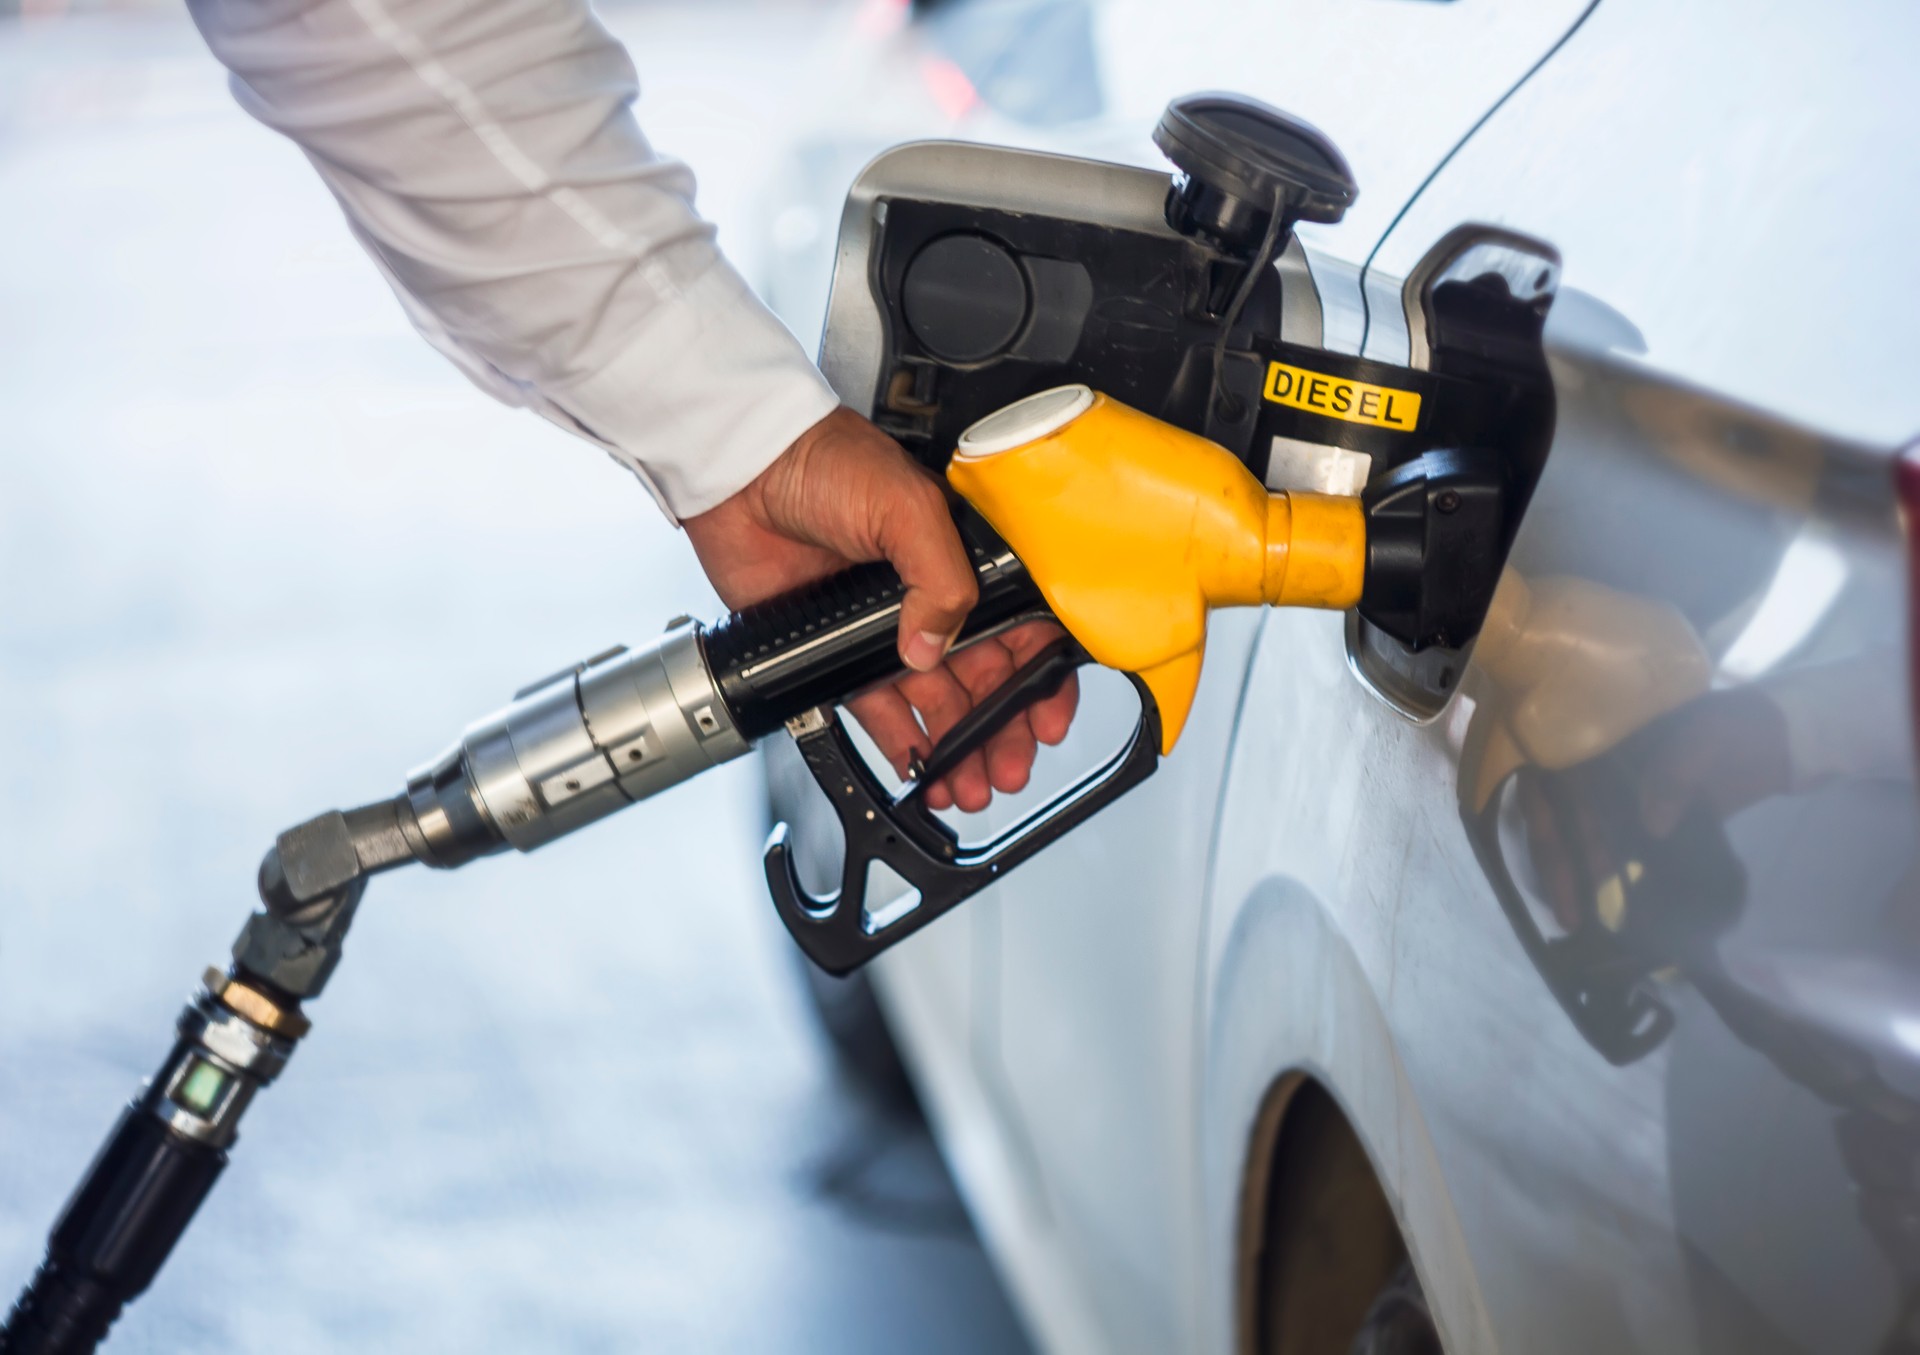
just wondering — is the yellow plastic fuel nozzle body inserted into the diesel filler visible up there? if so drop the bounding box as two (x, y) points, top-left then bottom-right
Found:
(947, 386), (1367, 752)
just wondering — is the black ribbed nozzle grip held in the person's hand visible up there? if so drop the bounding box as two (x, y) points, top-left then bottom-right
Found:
(701, 525), (1046, 741)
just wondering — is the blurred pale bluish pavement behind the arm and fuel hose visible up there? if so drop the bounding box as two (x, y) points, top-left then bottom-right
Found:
(0, 0), (1025, 1355)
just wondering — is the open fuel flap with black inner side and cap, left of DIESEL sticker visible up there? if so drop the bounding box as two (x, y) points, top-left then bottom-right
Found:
(820, 94), (1357, 472)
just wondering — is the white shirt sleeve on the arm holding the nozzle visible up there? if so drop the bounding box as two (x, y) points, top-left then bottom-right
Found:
(188, 0), (837, 518)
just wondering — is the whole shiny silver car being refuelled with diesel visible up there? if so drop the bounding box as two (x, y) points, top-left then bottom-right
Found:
(770, 0), (1920, 1355)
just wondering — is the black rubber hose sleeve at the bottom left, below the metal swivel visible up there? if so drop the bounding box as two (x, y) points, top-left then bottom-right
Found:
(0, 1105), (227, 1355)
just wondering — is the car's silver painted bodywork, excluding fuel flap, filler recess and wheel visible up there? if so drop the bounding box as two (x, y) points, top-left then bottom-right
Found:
(768, 0), (1920, 1351)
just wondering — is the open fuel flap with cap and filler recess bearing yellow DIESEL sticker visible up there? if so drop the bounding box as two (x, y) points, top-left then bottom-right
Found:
(822, 94), (1559, 716)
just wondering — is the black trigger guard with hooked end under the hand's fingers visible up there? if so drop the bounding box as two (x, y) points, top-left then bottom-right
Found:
(764, 639), (1160, 975)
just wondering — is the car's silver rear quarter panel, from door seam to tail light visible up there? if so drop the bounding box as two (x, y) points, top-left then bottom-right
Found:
(1202, 0), (1920, 1351)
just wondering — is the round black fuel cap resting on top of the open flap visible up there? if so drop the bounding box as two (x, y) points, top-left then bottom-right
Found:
(1154, 92), (1359, 255)
